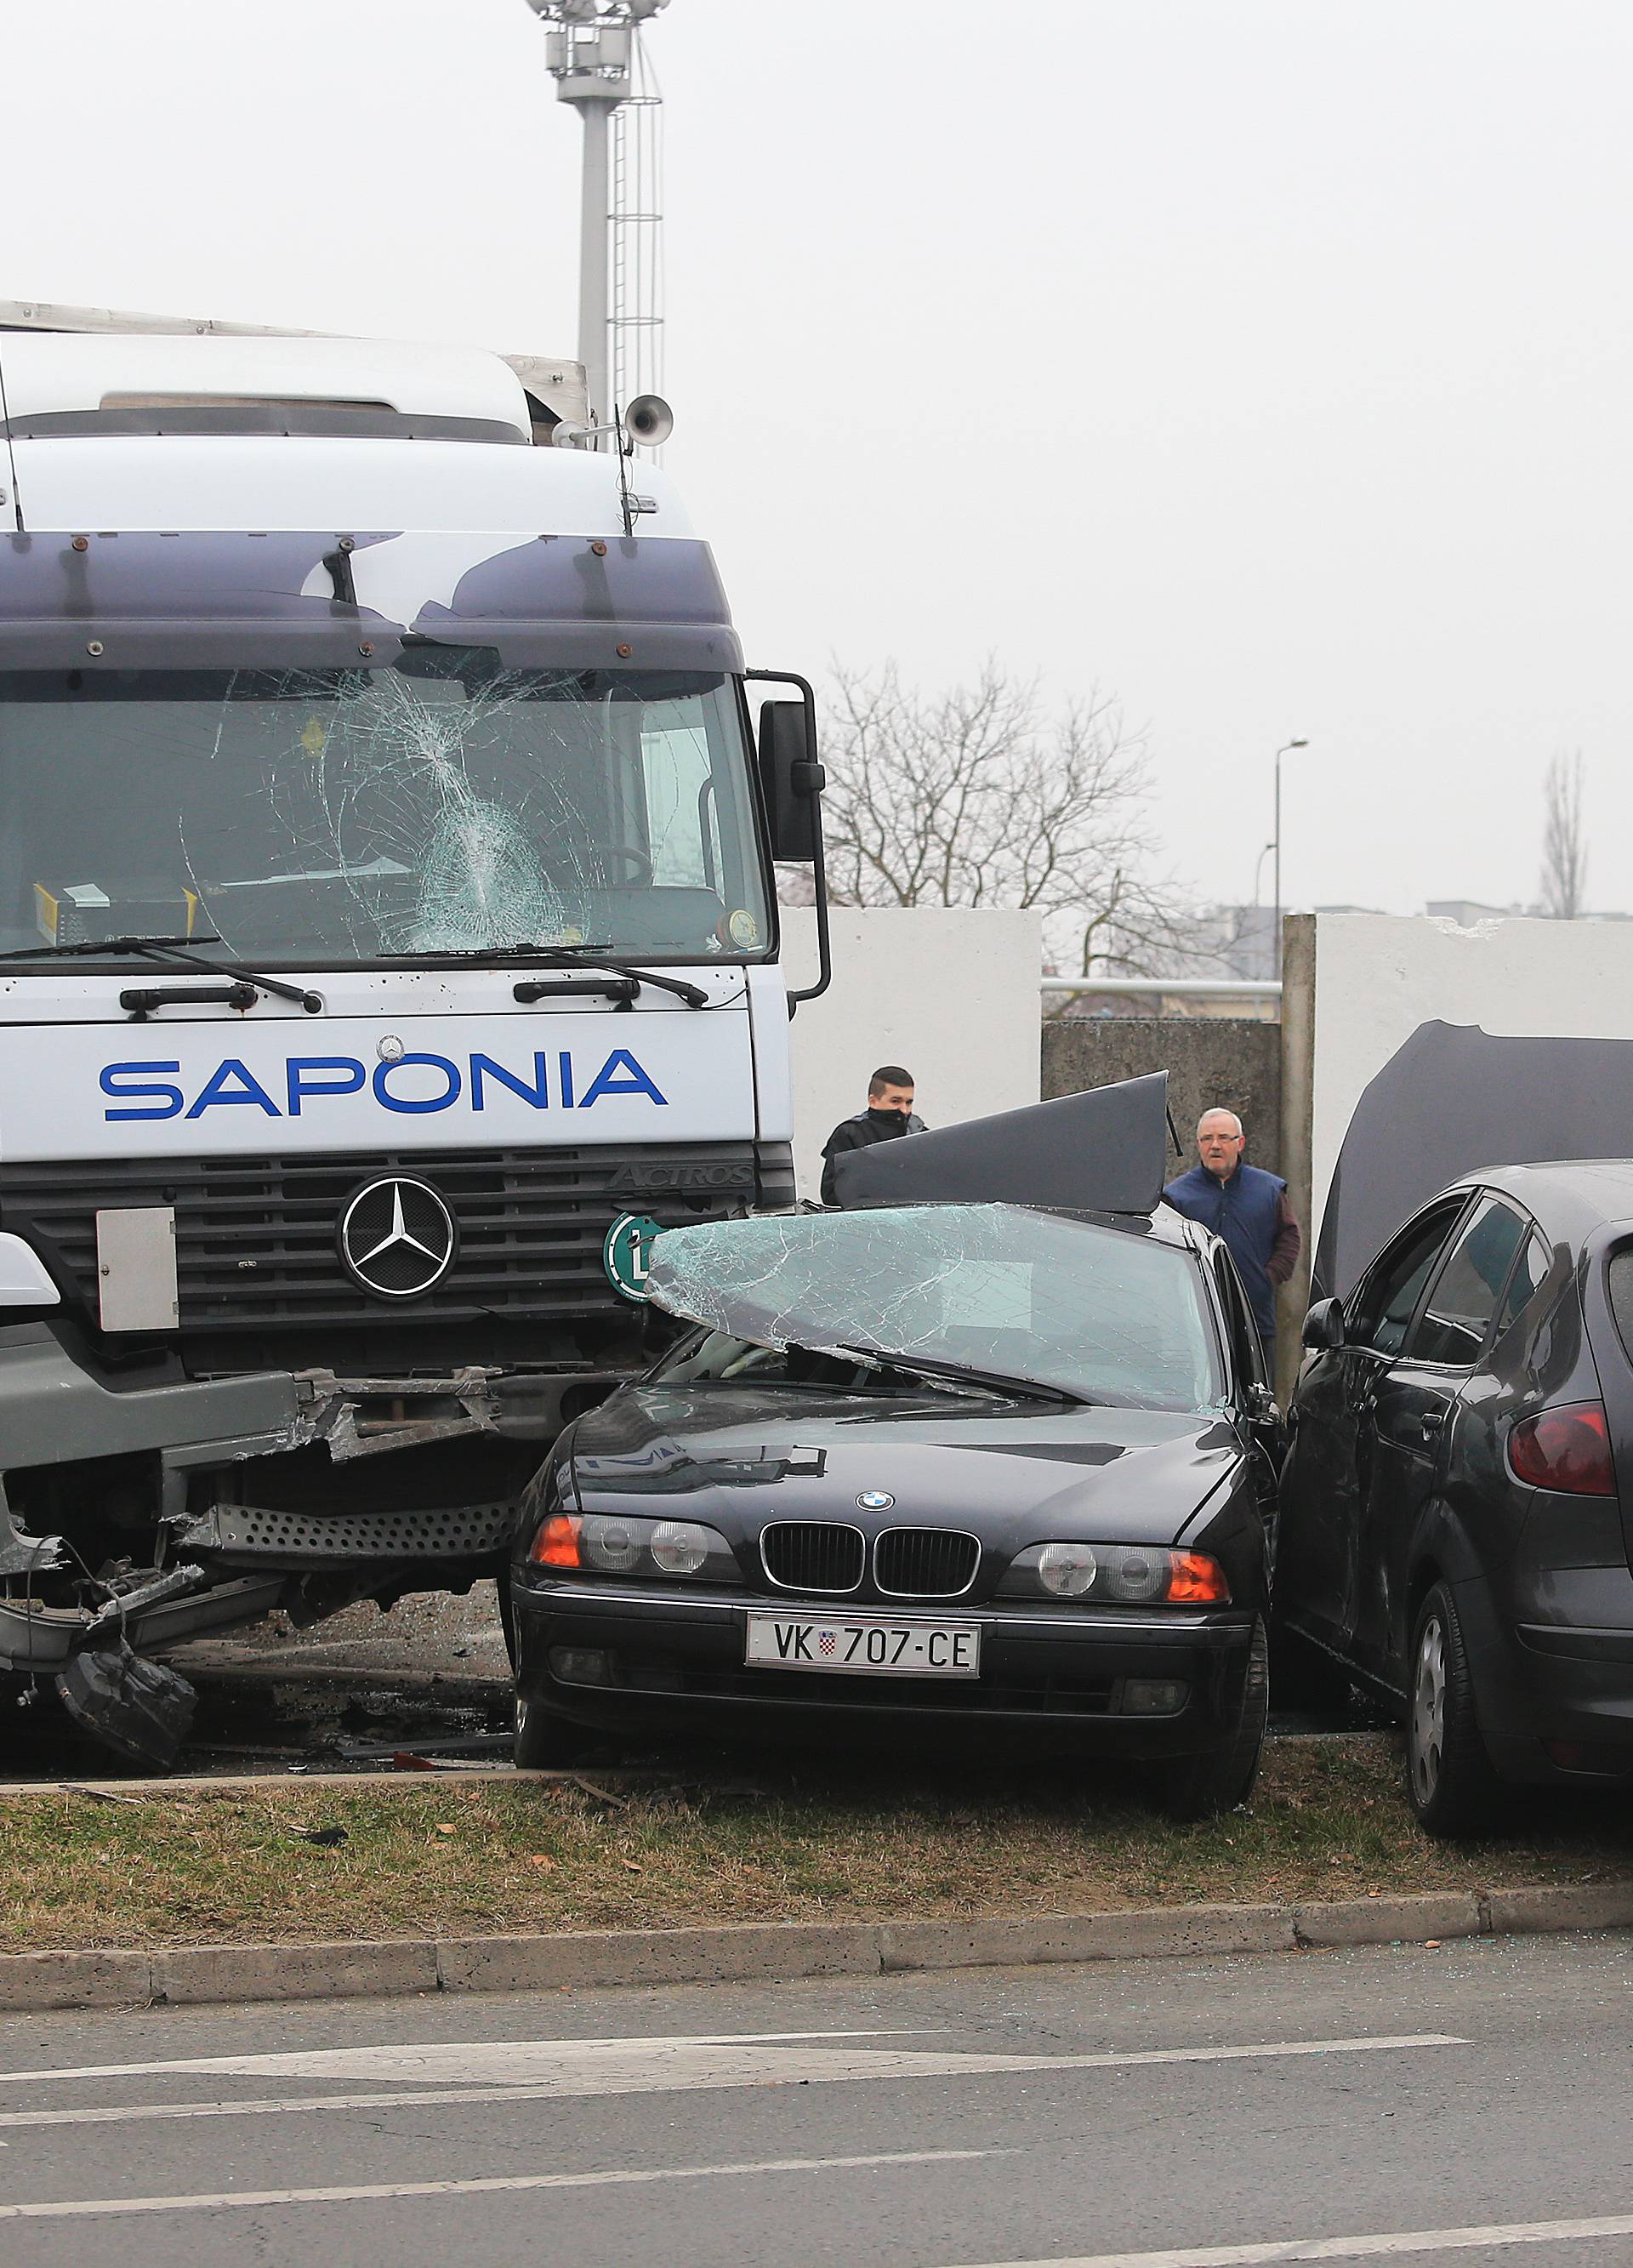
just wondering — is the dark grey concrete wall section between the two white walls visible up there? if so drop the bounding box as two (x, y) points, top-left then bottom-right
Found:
(1044, 1016), (1282, 1172)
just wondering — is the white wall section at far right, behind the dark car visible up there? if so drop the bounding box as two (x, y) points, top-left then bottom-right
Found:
(1289, 914), (1633, 1218)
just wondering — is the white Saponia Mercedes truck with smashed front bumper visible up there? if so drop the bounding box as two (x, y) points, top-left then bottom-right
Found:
(0, 306), (828, 1760)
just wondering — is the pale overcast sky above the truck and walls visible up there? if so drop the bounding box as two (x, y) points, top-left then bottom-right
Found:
(0, 0), (1633, 912)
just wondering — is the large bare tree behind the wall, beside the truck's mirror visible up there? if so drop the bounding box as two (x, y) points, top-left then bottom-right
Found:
(807, 660), (1184, 975)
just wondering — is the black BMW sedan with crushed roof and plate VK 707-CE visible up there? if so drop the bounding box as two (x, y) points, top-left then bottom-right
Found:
(510, 1205), (1277, 1816)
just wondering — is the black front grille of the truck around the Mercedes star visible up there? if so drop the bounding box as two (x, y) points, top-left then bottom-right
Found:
(0, 1141), (794, 1336)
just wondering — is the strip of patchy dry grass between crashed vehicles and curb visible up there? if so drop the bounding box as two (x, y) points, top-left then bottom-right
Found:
(0, 1735), (1633, 1952)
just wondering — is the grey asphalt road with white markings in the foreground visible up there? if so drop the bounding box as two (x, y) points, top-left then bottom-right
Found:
(0, 1937), (1633, 2268)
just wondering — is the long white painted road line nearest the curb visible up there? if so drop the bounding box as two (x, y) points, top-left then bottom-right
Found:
(0, 2032), (1467, 2129)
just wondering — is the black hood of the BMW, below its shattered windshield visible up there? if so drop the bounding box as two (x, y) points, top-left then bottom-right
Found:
(567, 1386), (1243, 1542)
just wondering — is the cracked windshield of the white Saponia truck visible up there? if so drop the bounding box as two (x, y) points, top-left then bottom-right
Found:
(0, 648), (769, 961)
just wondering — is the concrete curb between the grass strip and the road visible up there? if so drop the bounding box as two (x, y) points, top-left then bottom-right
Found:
(0, 1883), (1633, 2012)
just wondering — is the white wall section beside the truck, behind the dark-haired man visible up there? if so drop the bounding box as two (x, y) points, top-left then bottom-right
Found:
(782, 905), (1044, 1198)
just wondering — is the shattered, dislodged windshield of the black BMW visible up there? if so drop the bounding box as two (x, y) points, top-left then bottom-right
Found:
(646, 1205), (1225, 1410)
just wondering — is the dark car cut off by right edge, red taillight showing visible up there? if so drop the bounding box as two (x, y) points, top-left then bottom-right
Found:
(1275, 1159), (1633, 1835)
